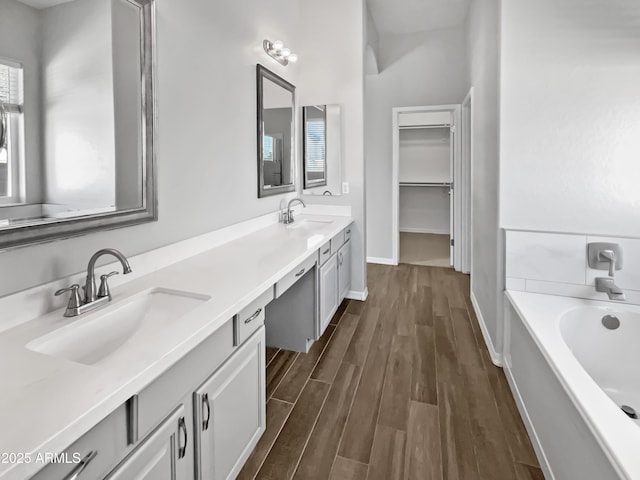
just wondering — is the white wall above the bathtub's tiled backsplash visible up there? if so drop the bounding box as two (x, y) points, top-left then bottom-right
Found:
(500, 0), (640, 236)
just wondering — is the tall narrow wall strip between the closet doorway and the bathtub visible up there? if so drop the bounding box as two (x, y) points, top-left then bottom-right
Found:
(467, 0), (506, 352)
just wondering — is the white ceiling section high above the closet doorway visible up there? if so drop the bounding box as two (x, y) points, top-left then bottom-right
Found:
(367, 0), (470, 35)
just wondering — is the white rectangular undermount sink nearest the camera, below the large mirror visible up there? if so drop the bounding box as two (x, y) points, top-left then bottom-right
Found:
(26, 288), (210, 365)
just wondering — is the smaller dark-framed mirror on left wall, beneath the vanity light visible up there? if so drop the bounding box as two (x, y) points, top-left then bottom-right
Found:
(256, 65), (296, 198)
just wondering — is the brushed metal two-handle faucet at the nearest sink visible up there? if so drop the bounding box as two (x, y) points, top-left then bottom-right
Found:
(55, 248), (131, 317)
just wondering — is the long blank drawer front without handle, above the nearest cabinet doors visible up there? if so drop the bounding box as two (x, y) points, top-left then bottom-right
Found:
(138, 319), (234, 439)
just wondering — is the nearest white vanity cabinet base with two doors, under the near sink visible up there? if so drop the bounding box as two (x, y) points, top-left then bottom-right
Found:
(32, 296), (273, 480)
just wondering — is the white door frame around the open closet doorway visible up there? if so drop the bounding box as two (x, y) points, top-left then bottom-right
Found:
(391, 104), (466, 271)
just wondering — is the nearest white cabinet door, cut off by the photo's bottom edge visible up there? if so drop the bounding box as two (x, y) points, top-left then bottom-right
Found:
(106, 405), (188, 480)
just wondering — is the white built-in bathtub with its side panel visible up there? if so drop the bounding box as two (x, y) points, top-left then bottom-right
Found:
(504, 291), (640, 480)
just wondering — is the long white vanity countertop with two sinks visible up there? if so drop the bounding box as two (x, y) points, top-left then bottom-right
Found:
(0, 215), (352, 480)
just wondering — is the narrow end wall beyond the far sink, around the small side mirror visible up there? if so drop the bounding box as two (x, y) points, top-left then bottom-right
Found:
(296, 0), (367, 292)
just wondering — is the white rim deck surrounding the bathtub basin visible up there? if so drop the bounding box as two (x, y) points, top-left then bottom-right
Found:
(506, 290), (640, 479)
